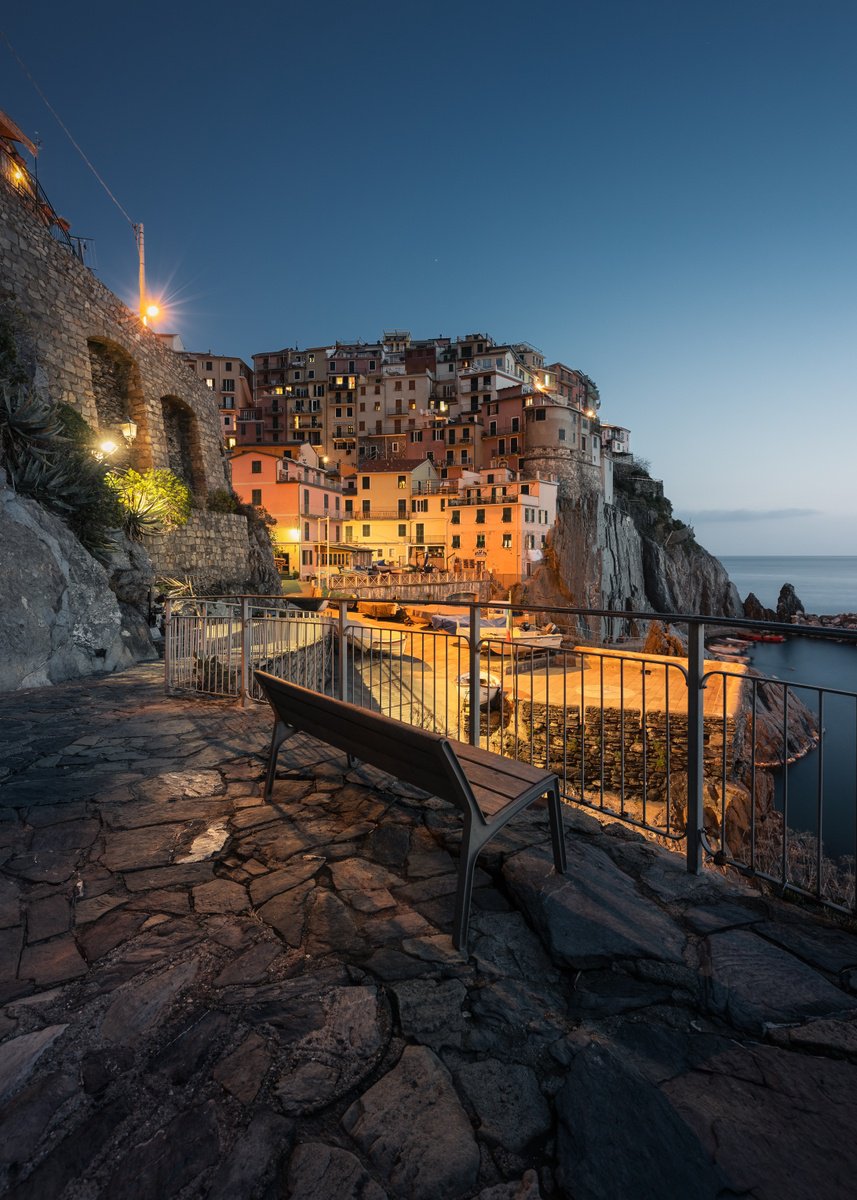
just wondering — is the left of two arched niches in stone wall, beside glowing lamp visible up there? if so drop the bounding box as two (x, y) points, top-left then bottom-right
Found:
(86, 337), (152, 469)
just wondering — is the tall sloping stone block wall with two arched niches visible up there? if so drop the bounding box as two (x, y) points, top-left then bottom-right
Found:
(0, 176), (227, 499)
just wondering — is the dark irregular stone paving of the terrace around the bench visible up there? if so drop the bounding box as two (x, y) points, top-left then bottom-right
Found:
(0, 666), (857, 1200)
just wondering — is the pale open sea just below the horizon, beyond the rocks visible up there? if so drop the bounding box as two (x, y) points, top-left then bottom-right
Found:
(720, 554), (857, 613)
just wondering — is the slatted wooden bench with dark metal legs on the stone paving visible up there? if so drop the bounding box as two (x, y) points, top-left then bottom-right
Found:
(254, 671), (565, 953)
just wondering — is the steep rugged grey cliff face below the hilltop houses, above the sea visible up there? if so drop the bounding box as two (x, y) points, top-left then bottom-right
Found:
(522, 463), (743, 617)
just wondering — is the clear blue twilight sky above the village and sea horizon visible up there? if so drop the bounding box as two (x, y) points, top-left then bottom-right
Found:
(0, 0), (857, 554)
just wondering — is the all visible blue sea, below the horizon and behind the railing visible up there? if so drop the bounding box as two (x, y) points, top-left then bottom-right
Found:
(720, 554), (857, 858)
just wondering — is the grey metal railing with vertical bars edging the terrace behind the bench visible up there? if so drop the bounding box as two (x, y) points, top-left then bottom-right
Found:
(166, 600), (857, 914)
